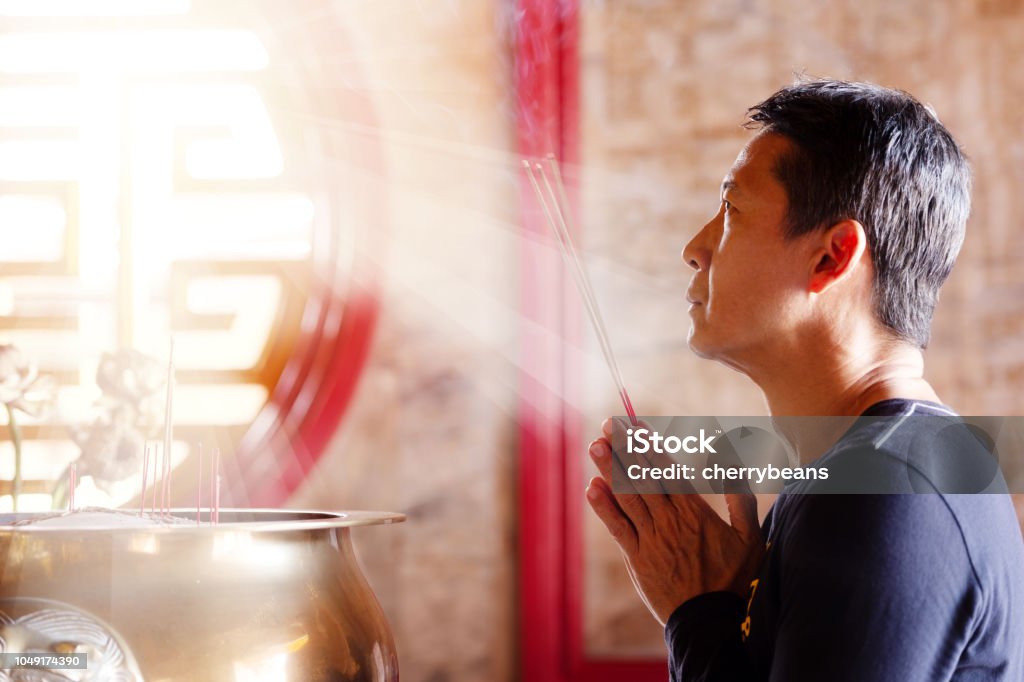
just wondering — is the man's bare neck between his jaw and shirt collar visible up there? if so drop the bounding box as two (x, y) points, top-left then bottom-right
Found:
(751, 333), (940, 464)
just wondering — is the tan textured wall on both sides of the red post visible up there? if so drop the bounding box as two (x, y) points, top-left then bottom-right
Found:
(293, 0), (1024, 680)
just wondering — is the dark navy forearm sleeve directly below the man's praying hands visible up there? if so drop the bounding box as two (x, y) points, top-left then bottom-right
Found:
(665, 592), (753, 682)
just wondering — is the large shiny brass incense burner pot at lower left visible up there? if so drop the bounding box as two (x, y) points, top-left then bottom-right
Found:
(0, 510), (403, 682)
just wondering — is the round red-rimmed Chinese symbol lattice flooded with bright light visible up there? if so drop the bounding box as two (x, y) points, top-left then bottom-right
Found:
(0, 0), (383, 506)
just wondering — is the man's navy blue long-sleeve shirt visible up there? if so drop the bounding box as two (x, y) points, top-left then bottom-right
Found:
(666, 400), (1024, 682)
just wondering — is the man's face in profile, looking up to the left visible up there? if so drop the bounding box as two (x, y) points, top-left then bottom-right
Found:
(682, 133), (812, 370)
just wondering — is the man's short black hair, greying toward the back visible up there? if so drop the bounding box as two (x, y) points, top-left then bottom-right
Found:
(746, 80), (971, 348)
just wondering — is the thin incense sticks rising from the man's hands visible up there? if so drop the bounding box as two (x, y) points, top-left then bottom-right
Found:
(522, 154), (638, 426)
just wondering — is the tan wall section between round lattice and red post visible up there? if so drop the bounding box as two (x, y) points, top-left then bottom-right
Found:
(290, 0), (519, 682)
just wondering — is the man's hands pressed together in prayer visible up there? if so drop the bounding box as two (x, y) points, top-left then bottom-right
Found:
(587, 419), (764, 626)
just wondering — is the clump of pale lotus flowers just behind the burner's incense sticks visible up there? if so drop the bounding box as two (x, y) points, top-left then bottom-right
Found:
(62, 348), (166, 507)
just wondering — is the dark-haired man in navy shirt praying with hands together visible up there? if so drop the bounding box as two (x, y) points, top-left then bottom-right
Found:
(587, 81), (1024, 682)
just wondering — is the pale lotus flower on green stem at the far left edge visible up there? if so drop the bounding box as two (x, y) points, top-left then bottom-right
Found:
(0, 344), (56, 511)
